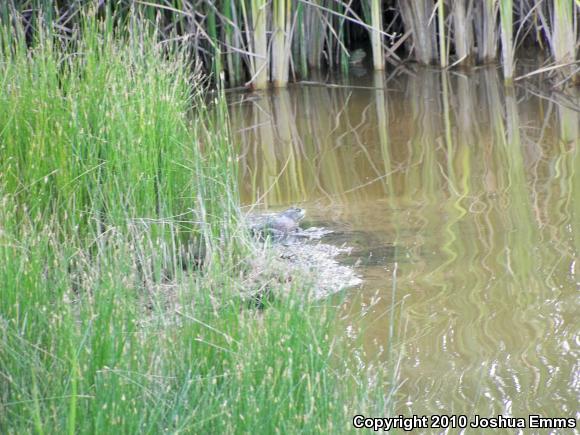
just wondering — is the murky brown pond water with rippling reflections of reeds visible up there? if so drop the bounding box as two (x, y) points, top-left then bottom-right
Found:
(230, 70), (580, 417)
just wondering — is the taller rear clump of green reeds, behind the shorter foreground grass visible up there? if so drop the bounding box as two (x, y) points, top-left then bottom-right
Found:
(0, 13), (247, 264)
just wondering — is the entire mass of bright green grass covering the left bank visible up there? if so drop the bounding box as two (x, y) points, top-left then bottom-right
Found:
(0, 11), (387, 434)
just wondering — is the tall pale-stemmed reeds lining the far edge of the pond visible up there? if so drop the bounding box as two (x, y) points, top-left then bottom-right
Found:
(4, 0), (580, 89)
